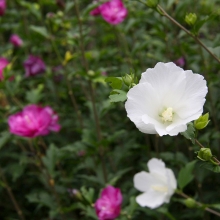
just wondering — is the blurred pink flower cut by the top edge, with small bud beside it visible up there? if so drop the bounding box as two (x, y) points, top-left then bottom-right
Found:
(90, 0), (128, 25)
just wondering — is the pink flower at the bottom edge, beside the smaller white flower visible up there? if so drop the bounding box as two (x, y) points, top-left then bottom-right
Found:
(95, 186), (122, 220)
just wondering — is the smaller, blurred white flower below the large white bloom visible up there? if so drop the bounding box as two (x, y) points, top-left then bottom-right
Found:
(134, 158), (177, 209)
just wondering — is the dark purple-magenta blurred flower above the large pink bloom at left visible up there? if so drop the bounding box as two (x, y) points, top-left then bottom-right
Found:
(23, 55), (46, 76)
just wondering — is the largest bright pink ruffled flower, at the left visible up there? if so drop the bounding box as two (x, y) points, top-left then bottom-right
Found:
(8, 104), (60, 138)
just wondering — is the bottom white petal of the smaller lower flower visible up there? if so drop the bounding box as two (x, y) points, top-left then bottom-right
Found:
(136, 190), (167, 209)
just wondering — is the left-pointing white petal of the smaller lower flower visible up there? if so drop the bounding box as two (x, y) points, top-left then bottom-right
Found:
(134, 171), (157, 192)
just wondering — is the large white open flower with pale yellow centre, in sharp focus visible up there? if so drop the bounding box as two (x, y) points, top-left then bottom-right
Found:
(125, 62), (208, 136)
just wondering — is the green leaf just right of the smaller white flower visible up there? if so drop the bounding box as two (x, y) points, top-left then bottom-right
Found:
(177, 160), (197, 190)
